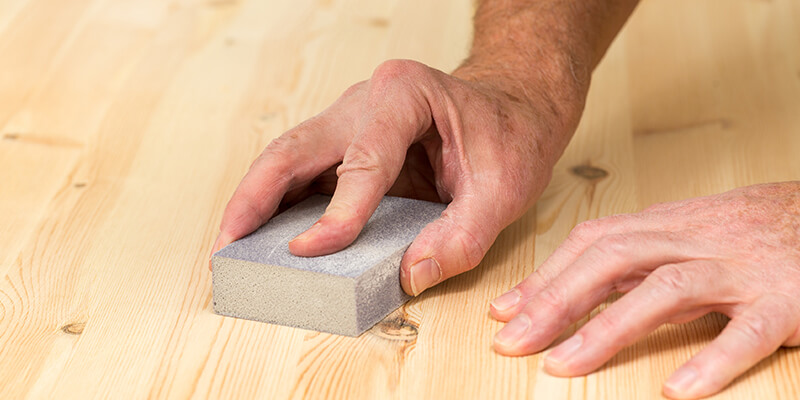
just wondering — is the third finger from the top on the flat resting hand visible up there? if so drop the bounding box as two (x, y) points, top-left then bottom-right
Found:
(545, 260), (746, 376)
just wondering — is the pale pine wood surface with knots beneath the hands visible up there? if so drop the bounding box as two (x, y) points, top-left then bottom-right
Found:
(0, 0), (800, 399)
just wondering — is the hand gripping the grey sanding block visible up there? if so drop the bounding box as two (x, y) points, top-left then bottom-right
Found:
(206, 60), (583, 295)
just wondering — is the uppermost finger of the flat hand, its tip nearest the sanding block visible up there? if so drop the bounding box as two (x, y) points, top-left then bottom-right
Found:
(489, 214), (660, 321)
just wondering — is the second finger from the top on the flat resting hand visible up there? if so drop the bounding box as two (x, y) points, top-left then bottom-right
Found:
(494, 232), (701, 355)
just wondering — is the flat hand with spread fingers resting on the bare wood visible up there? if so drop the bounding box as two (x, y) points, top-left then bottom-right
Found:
(491, 182), (800, 398)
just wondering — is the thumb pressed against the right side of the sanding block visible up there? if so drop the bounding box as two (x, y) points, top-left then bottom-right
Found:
(400, 197), (501, 296)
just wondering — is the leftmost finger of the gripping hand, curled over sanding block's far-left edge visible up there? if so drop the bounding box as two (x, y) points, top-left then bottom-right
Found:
(212, 117), (344, 254)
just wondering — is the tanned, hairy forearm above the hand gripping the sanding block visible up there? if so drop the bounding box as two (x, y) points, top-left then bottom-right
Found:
(454, 0), (638, 155)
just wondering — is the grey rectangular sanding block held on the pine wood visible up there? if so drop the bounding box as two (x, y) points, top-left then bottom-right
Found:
(211, 195), (445, 336)
